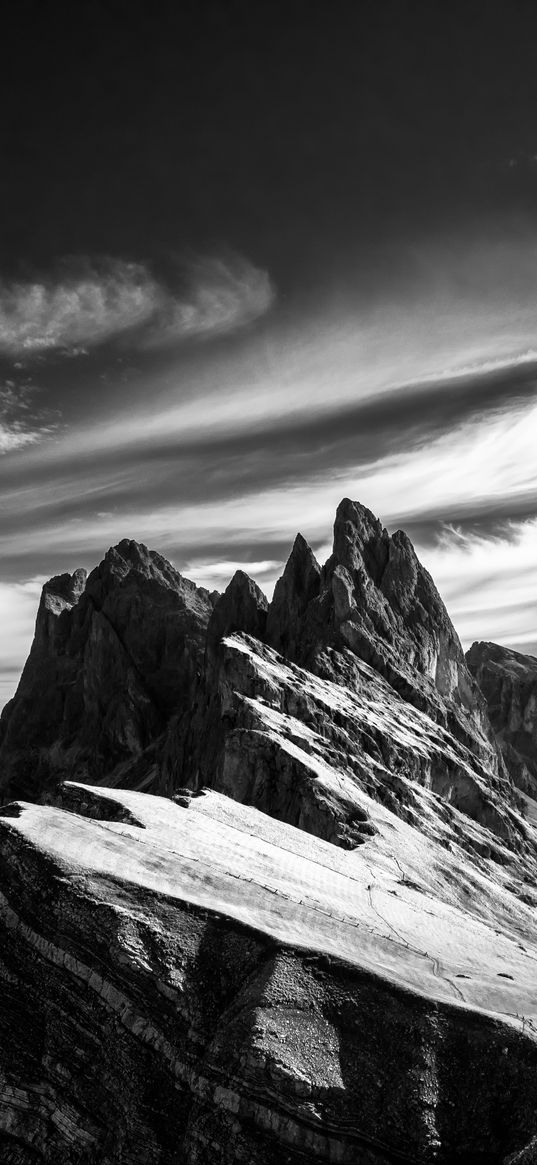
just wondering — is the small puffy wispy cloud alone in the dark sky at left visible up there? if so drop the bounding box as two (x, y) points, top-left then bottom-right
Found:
(0, 255), (274, 356)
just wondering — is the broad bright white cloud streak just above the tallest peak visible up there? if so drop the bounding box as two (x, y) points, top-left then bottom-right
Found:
(1, 372), (537, 563)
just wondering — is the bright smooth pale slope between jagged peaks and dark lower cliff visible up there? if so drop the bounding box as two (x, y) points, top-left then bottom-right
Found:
(2, 785), (537, 1038)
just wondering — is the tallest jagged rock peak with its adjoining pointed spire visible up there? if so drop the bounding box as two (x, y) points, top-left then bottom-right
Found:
(268, 499), (488, 733)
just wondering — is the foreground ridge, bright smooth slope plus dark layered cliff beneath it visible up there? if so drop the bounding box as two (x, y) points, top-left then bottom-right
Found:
(0, 785), (537, 1165)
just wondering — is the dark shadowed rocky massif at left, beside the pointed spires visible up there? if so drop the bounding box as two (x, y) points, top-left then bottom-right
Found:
(0, 541), (213, 798)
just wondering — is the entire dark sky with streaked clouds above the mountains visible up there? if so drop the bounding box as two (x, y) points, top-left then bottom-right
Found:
(0, 0), (537, 705)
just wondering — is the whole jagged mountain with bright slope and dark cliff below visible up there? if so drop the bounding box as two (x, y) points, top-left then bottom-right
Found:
(0, 500), (537, 1165)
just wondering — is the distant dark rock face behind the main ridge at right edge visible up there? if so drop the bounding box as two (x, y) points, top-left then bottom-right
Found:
(466, 643), (537, 798)
